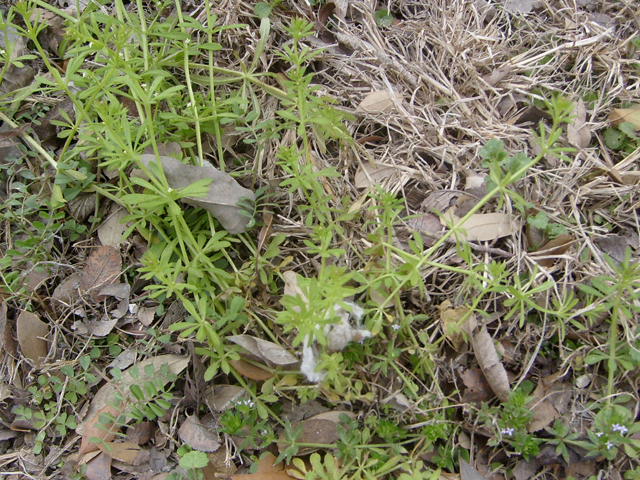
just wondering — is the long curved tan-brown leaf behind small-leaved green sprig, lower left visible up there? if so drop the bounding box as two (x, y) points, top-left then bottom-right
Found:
(76, 355), (189, 435)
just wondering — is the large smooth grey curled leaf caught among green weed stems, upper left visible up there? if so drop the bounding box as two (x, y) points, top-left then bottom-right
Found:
(140, 155), (256, 233)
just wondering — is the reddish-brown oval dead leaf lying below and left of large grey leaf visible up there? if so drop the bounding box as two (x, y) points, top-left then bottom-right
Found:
(80, 246), (122, 303)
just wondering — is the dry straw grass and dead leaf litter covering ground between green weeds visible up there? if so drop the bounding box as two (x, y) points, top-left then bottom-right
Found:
(0, 1), (640, 480)
